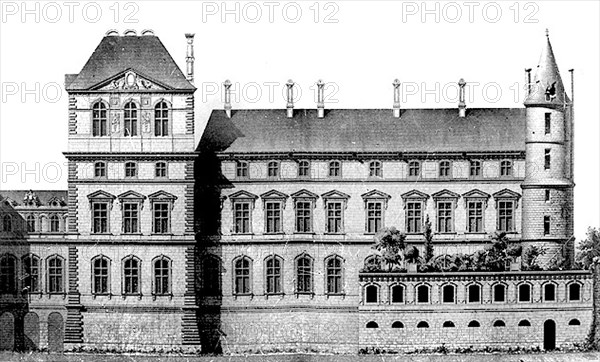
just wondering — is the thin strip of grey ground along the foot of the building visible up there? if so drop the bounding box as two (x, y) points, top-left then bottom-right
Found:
(0, 352), (600, 362)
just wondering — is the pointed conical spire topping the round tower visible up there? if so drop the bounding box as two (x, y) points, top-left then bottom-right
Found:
(525, 29), (570, 107)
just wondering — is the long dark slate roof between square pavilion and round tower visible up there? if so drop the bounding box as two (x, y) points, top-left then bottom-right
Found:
(199, 108), (525, 153)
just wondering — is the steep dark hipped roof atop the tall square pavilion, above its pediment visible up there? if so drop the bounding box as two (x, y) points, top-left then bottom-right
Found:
(65, 35), (195, 90)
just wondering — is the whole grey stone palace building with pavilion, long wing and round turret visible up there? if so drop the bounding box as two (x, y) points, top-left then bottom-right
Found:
(0, 30), (593, 353)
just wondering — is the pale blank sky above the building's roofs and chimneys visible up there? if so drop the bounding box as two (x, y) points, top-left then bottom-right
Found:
(0, 1), (600, 240)
